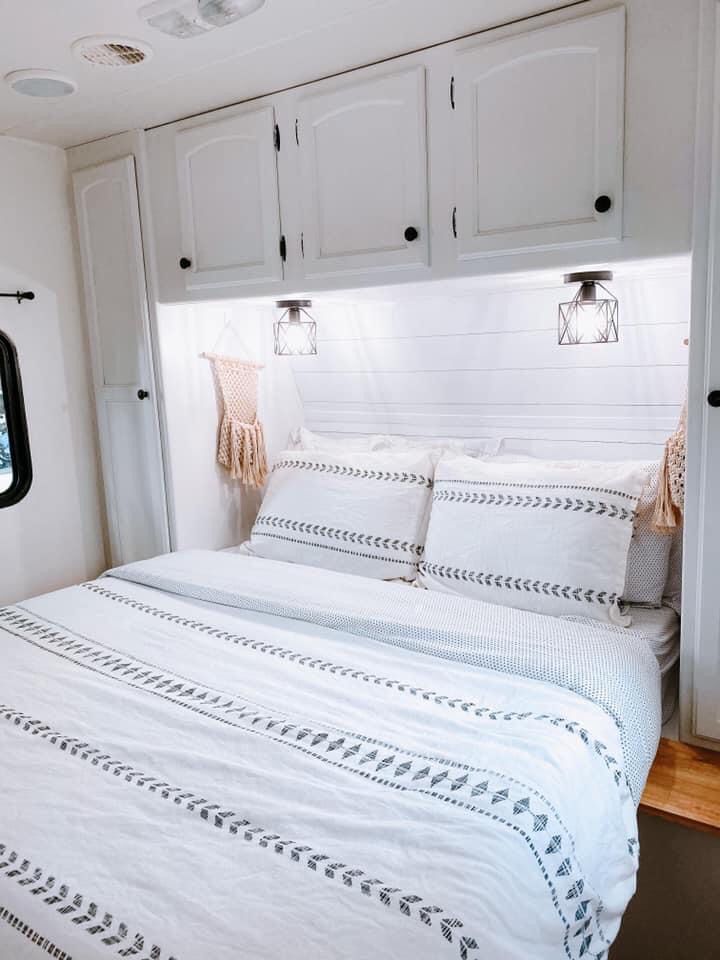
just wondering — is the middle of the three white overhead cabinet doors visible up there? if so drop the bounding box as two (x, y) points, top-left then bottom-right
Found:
(298, 67), (429, 277)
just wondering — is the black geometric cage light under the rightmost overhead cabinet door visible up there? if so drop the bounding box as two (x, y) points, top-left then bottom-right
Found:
(558, 270), (619, 346)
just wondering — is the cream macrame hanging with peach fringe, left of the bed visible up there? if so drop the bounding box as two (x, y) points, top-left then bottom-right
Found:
(203, 353), (268, 487)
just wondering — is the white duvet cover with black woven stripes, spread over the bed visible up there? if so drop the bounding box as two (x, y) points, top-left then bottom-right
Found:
(0, 552), (660, 960)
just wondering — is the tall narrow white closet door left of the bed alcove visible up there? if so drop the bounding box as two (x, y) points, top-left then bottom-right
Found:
(73, 157), (169, 564)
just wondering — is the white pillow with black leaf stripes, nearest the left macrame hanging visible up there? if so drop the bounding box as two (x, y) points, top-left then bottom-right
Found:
(245, 450), (434, 580)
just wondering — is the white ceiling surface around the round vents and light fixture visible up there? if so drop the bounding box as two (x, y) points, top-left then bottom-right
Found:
(0, 0), (572, 147)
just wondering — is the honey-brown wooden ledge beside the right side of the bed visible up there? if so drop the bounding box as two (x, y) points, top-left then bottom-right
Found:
(640, 740), (720, 835)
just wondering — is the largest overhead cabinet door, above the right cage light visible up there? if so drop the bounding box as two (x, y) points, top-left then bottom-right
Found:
(453, 8), (625, 260)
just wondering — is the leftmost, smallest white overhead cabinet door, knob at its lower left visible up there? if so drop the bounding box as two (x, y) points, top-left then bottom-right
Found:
(175, 107), (283, 290)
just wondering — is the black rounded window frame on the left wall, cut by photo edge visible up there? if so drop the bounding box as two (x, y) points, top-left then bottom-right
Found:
(0, 330), (33, 510)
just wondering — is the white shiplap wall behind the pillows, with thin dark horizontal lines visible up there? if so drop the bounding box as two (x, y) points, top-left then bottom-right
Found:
(291, 259), (690, 460)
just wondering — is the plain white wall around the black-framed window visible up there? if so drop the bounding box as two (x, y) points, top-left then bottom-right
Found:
(0, 137), (105, 604)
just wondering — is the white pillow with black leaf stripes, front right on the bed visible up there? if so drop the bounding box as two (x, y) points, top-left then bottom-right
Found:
(420, 457), (646, 620)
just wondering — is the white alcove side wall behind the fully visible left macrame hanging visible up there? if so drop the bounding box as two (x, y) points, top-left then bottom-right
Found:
(158, 302), (303, 550)
